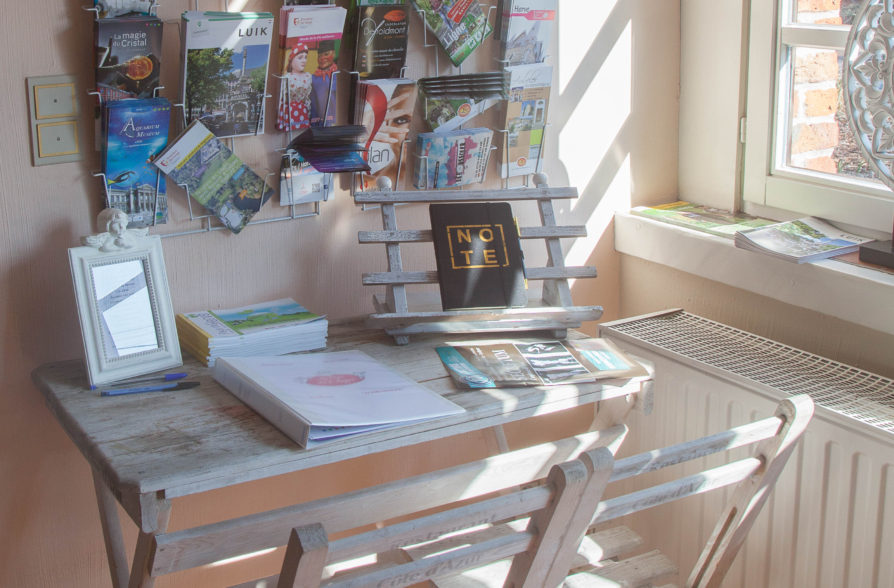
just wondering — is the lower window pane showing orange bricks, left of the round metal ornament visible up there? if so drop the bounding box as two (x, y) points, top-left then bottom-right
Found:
(784, 47), (875, 178)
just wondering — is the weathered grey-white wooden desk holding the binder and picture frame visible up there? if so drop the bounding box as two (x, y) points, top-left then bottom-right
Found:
(32, 322), (651, 587)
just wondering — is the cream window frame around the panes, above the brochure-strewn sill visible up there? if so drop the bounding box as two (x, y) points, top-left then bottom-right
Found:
(742, 0), (894, 234)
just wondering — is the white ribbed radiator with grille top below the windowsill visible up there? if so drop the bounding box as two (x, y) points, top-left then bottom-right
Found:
(600, 310), (894, 588)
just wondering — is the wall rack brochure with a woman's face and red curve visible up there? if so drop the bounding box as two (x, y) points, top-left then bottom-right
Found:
(355, 79), (416, 190)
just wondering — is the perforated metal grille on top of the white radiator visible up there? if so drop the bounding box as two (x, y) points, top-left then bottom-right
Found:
(600, 310), (894, 433)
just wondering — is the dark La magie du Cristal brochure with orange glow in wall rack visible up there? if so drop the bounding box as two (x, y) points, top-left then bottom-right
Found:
(94, 16), (162, 102)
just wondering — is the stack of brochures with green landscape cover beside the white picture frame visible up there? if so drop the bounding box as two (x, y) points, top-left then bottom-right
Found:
(176, 298), (329, 366)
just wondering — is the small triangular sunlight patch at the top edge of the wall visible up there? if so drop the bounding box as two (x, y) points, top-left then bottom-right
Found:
(553, 0), (617, 93)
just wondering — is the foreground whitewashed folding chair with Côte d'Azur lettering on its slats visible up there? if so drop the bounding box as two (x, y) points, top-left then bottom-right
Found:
(256, 396), (813, 588)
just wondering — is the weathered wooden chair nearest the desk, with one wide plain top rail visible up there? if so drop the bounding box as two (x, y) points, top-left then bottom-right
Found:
(144, 425), (627, 588)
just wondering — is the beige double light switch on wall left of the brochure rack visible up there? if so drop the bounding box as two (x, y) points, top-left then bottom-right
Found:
(27, 76), (83, 165)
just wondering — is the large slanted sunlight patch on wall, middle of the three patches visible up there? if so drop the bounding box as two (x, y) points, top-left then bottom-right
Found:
(559, 23), (633, 190)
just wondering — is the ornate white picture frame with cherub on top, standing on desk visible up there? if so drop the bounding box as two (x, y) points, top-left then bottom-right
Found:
(68, 209), (183, 386)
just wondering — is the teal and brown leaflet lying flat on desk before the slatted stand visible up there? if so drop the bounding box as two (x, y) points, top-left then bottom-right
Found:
(435, 338), (648, 389)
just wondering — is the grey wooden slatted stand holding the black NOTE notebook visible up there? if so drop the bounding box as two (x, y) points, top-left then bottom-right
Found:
(354, 174), (602, 345)
